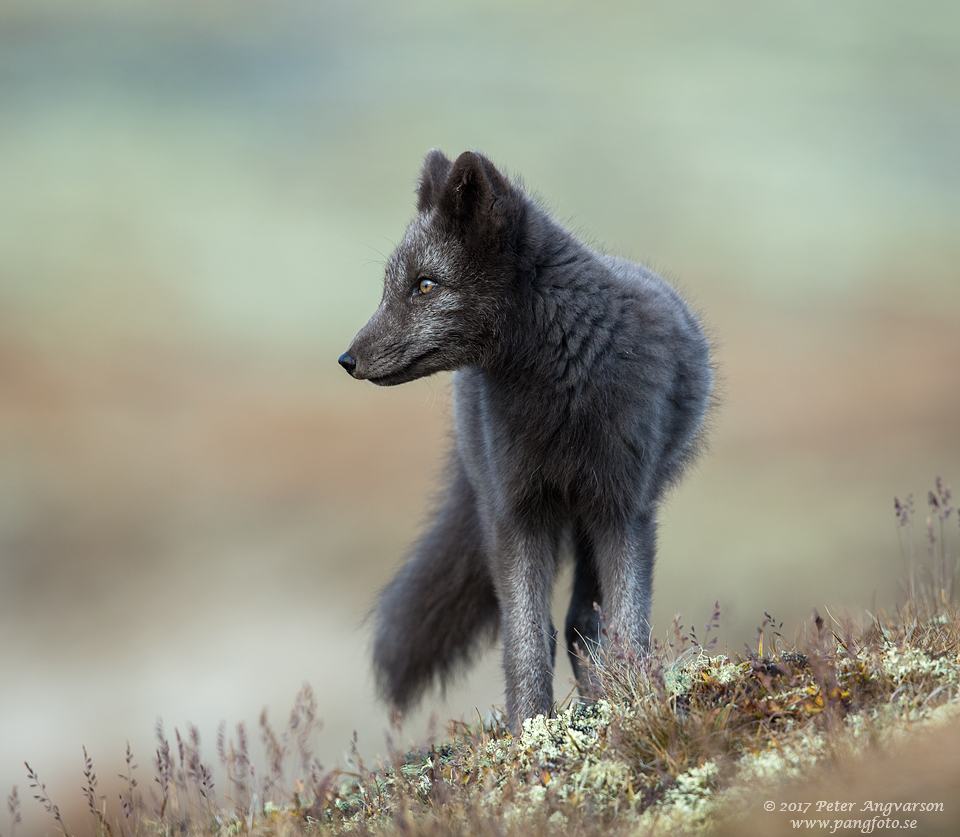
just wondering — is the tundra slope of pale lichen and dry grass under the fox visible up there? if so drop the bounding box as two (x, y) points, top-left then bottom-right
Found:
(4, 478), (960, 837)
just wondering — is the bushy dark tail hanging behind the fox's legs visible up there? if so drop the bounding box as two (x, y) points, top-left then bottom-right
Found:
(373, 454), (499, 711)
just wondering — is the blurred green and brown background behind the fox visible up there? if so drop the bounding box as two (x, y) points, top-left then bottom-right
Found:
(0, 0), (960, 833)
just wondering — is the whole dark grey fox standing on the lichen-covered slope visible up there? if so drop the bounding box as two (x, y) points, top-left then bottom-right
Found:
(340, 151), (713, 731)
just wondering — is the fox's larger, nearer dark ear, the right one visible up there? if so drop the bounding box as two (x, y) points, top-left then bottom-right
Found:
(437, 151), (522, 242)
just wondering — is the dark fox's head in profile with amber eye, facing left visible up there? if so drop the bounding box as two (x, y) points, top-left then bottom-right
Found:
(340, 150), (526, 386)
